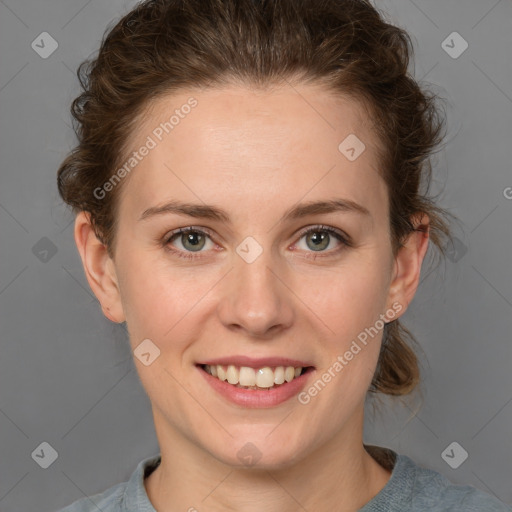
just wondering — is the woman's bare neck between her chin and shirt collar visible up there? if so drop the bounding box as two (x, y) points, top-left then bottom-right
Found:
(144, 408), (391, 512)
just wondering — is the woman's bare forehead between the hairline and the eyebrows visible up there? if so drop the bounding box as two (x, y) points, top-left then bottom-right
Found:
(118, 85), (386, 222)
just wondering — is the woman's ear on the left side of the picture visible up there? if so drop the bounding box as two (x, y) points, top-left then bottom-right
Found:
(75, 211), (125, 323)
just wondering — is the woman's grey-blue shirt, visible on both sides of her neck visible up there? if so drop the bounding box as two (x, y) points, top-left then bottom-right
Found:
(58, 446), (512, 512)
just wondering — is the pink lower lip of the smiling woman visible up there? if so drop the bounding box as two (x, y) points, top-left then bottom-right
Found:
(196, 366), (314, 409)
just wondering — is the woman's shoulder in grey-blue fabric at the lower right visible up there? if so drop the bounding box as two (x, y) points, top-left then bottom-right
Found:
(398, 455), (512, 512)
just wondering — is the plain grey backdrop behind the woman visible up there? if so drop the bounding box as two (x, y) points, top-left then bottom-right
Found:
(0, 0), (512, 512)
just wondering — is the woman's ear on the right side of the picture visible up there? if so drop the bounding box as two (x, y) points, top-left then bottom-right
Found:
(388, 214), (430, 314)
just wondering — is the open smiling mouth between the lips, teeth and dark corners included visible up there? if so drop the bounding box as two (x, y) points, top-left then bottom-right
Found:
(198, 364), (314, 390)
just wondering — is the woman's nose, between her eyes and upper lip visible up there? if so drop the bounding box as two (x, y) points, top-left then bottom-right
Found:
(218, 246), (294, 339)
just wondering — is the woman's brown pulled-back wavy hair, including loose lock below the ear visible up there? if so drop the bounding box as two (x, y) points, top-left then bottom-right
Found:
(58, 0), (456, 395)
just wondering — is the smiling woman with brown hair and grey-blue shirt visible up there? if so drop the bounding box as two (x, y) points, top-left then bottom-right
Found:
(58, 0), (509, 512)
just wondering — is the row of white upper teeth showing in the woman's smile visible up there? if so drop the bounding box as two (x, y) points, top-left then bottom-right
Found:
(204, 364), (302, 388)
